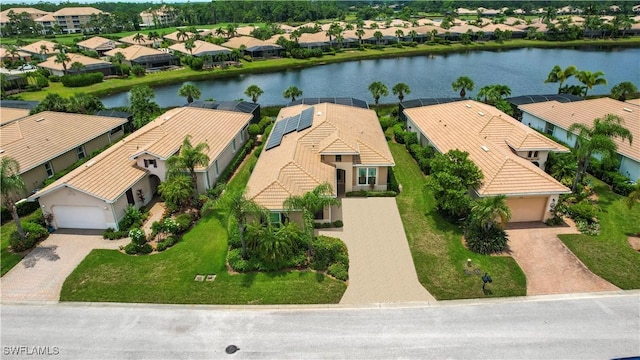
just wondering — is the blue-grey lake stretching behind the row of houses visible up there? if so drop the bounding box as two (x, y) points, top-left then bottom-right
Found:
(101, 48), (640, 108)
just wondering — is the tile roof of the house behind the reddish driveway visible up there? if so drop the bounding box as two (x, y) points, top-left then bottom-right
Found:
(404, 100), (569, 196)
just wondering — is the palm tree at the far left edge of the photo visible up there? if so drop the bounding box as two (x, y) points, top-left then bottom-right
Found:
(0, 156), (26, 239)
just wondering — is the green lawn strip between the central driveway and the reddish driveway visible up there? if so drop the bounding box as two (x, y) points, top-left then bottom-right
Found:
(389, 142), (526, 300)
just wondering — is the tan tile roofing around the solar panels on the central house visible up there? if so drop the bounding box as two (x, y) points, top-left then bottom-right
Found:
(247, 103), (394, 210)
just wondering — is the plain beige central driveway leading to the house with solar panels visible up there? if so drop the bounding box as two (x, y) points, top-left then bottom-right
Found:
(319, 198), (435, 304)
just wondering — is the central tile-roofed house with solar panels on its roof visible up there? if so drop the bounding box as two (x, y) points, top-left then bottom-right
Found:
(247, 103), (395, 221)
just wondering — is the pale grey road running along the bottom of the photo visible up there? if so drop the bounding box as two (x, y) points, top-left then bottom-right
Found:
(1, 291), (640, 359)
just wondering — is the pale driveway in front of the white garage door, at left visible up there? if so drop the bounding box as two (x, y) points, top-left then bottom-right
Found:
(0, 231), (130, 303)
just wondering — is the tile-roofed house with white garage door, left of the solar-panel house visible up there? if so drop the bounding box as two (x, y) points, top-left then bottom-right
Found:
(31, 107), (253, 229)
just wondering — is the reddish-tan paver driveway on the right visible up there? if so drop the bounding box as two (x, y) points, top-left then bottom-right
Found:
(507, 223), (620, 295)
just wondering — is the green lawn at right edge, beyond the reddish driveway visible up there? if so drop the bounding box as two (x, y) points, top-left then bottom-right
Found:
(559, 178), (640, 289)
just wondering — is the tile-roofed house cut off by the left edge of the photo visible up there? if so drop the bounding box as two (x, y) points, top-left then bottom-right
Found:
(0, 111), (127, 197)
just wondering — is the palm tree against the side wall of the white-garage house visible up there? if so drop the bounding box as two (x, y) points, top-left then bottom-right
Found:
(167, 135), (209, 206)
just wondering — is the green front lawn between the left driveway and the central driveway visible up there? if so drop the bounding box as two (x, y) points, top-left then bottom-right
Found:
(60, 155), (346, 304)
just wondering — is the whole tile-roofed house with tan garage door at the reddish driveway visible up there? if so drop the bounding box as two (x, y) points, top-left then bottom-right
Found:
(404, 100), (570, 222)
